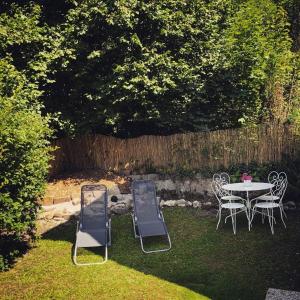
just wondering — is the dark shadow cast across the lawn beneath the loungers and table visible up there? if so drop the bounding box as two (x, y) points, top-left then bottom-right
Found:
(43, 208), (300, 300)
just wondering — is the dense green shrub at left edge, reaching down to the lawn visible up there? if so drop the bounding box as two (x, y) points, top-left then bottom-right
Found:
(0, 59), (51, 270)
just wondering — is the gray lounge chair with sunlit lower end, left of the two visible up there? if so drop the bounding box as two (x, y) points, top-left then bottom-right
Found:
(73, 185), (111, 266)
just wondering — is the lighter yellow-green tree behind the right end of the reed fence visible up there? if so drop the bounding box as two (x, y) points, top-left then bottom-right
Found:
(207, 0), (293, 128)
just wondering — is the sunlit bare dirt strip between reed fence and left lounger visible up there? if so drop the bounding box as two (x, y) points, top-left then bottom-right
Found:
(42, 170), (130, 205)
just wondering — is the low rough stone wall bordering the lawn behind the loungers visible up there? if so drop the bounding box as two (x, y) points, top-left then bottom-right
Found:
(38, 174), (296, 232)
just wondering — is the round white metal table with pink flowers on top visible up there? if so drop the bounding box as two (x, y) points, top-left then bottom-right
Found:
(222, 182), (274, 230)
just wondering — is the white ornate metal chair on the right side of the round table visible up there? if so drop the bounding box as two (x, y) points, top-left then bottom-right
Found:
(251, 171), (288, 234)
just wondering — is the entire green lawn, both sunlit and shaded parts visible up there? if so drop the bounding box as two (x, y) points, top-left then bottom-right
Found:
(0, 208), (300, 300)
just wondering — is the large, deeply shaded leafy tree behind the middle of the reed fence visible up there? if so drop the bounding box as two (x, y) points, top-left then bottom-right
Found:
(40, 0), (230, 136)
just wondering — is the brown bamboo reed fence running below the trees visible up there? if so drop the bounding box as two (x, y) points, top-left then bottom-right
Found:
(51, 124), (299, 175)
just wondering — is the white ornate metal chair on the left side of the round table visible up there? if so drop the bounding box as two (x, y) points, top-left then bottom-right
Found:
(211, 172), (249, 234)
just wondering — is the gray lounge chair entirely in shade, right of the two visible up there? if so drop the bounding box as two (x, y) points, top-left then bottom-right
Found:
(132, 180), (171, 253)
